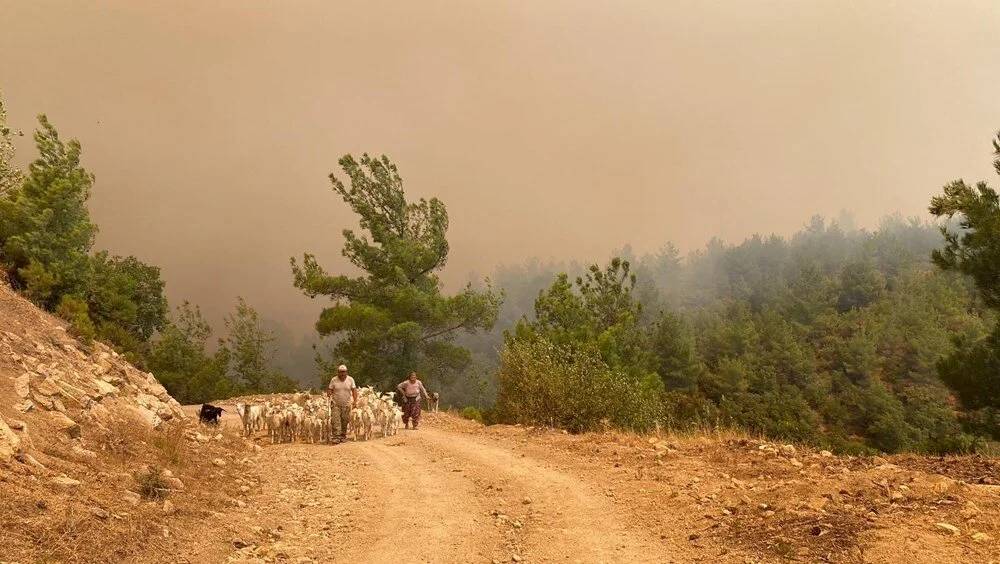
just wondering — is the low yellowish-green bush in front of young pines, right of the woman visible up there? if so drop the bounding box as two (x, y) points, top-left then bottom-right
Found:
(495, 336), (662, 433)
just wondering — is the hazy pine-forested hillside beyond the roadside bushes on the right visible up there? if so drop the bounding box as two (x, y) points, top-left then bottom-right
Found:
(445, 216), (997, 452)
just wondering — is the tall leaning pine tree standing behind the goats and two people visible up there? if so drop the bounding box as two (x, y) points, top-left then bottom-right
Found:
(291, 154), (503, 385)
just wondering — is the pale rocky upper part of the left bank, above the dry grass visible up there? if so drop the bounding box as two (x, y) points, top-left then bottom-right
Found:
(0, 287), (185, 472)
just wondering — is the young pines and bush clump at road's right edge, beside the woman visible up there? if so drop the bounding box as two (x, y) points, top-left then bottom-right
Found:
(496, 258), (663, 432)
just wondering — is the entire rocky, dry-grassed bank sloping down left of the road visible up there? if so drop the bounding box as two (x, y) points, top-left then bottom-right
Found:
(0, 283), (253, 562)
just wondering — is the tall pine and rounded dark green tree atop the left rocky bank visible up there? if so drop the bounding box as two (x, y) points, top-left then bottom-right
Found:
(0, 107), (167, 365)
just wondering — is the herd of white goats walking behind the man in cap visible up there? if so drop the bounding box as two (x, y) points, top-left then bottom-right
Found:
(199, 387), (403, 443)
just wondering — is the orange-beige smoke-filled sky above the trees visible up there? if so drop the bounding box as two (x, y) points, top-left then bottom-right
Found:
(0, 0), (1000, 340)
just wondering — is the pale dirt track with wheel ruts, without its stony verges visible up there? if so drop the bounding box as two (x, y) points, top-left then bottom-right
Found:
(172, 414), (700, 563)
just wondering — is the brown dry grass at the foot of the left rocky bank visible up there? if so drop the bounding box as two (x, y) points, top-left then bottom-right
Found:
(0, 423), (250, 562)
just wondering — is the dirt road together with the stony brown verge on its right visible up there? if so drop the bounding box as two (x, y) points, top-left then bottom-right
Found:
(171, 415), (1000, 564)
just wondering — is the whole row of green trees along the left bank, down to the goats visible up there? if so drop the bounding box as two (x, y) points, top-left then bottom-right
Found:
(0, 100), (295, 403)
